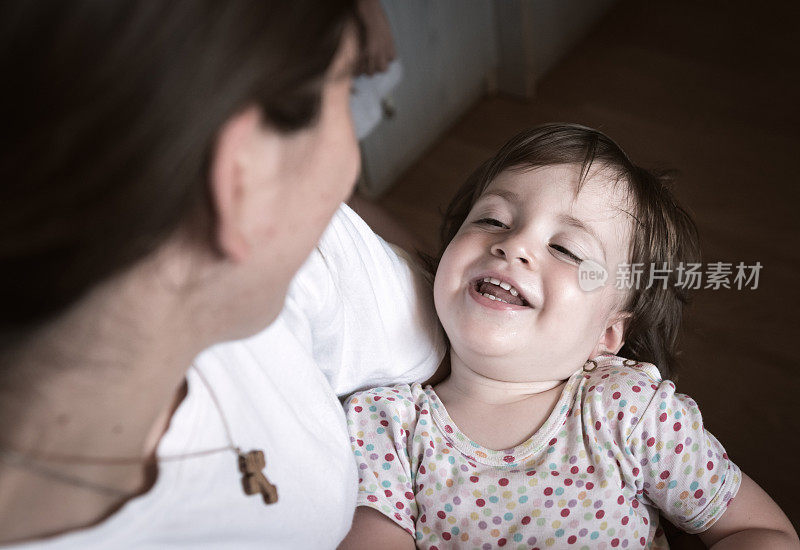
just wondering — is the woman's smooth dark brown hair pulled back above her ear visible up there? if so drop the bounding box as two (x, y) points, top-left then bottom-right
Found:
(0, 0), (354, 349)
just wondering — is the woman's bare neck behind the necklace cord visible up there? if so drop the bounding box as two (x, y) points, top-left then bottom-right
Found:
(0, 262), (210, 543)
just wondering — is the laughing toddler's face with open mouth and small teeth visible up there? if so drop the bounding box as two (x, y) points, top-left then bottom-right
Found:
(434, 165), (631, 382)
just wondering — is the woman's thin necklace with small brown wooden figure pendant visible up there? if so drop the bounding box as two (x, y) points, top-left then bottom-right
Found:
(0, 365), (278, 504)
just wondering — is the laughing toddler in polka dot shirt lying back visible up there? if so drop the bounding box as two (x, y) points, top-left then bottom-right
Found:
(338, 124), (797, 549)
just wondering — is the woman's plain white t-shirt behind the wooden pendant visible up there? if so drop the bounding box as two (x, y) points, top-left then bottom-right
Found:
(7, 205), (445, 549)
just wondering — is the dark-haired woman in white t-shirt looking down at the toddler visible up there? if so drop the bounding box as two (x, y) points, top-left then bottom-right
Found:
(0, 0), (443, 548)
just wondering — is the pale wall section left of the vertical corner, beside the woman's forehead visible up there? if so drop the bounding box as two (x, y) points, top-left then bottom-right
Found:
(362, 0), (497, 195)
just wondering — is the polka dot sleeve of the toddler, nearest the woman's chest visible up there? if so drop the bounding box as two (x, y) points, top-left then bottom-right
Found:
(345, 386), (417, 536)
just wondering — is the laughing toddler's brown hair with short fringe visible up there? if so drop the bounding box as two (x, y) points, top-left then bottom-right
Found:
(432, 123), (700, 377)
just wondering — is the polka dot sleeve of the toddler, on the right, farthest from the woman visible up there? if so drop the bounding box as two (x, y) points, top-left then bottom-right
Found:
(629, 381), (741, 533)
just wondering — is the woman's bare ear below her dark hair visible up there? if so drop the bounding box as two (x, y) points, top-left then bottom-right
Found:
(210, 106), (276, 263)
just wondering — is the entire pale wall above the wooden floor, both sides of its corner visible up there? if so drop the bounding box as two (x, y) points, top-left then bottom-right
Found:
(362, 0), (616, 195)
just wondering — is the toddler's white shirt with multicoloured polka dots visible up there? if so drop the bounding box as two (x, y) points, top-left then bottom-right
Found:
(345, 355), (741, 549)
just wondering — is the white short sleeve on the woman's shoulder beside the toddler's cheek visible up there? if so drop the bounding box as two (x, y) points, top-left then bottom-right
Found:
(282, 204), (446, 396)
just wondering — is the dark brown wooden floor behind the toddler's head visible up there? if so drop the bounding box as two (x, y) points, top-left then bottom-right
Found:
(380, 0), (800, 527)
